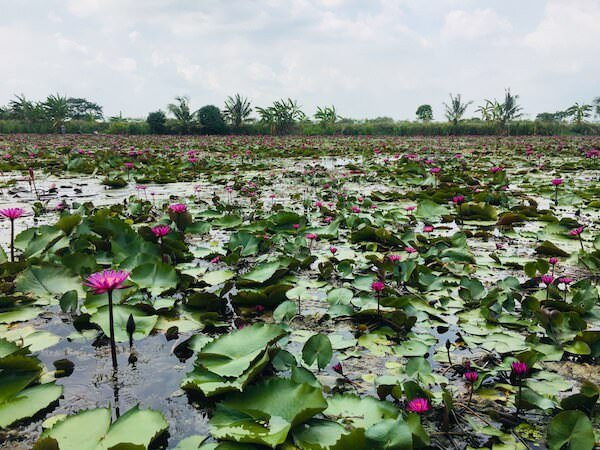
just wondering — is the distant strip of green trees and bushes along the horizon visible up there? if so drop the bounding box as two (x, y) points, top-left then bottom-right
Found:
(0, 89), (600, 136)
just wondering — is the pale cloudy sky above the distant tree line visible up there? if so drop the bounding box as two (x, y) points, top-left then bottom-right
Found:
(0, 0), (600, 120)
